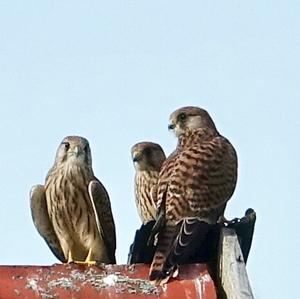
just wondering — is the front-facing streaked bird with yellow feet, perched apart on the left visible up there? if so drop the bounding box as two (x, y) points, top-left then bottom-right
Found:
(30, 136), (116, 264)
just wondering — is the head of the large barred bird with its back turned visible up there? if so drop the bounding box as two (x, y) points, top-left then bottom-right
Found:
(168, 106), (216, 137)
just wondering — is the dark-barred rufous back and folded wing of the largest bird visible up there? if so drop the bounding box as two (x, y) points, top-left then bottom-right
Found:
(166, 136), (237, 223)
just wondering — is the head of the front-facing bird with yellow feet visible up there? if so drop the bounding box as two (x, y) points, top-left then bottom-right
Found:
(55, 136), (92, 166)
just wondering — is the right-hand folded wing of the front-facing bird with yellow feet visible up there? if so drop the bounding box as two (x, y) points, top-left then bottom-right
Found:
(89, 180), (116, 264)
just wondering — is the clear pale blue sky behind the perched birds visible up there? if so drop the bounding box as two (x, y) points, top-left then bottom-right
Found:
(0, 0), (300, 299)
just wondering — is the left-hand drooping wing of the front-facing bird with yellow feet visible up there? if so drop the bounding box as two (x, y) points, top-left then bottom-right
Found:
(30, 185), (66, 263)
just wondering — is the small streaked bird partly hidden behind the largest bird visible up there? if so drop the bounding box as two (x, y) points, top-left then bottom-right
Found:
(131, 142), (166, 224)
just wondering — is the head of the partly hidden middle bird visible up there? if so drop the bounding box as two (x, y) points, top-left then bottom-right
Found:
(131, 142), (166, 171)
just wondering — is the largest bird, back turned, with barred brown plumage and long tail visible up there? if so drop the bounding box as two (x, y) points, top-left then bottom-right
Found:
(149, 107), (237, 284)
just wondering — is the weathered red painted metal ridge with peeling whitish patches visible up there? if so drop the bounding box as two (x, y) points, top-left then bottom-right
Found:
(0, 264), (217, 299)
